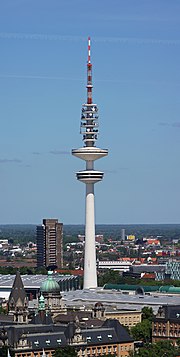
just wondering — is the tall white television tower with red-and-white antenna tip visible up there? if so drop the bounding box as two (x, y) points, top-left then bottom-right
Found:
(72, 37), (108, 289)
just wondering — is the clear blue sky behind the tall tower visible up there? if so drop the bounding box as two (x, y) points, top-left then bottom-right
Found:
(0, 0), (180, 224)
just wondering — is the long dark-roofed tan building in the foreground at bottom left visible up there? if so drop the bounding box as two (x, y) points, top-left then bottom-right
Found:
(4, 318), (134, 357)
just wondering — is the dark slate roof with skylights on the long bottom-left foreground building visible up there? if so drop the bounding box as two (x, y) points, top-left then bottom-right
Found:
(6, 319), (133, 350)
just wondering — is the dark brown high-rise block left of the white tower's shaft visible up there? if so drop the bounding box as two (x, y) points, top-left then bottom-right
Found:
(36, 219), (63, 269)
